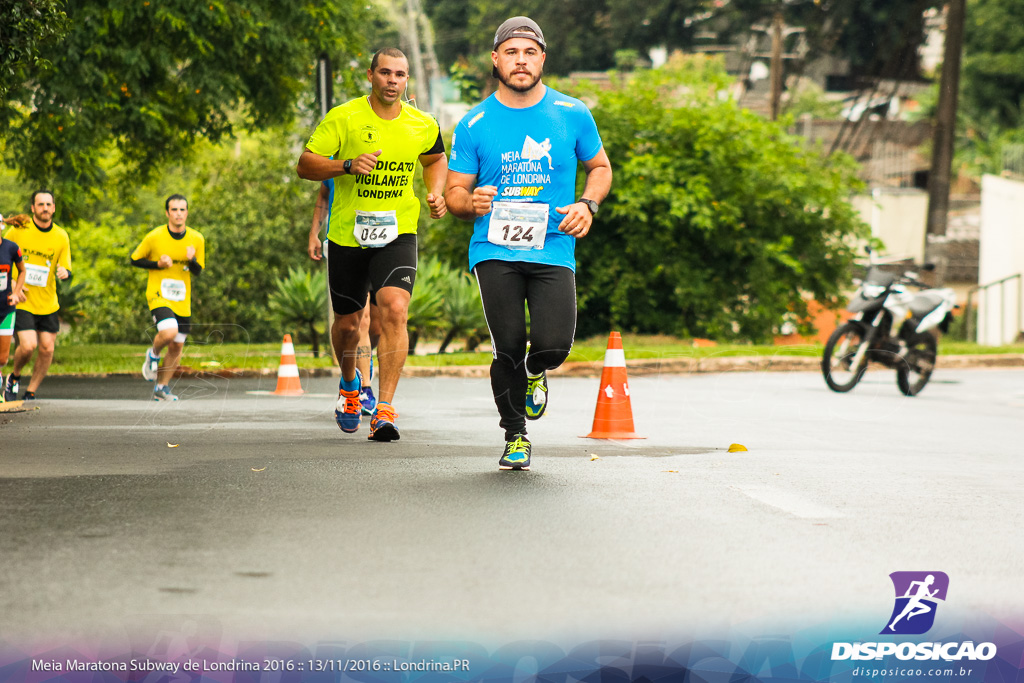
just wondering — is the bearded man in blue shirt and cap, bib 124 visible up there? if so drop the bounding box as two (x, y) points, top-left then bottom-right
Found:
(444, 16), (611, 470)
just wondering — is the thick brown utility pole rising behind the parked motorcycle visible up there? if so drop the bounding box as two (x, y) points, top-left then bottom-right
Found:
(925, 0), (967, 237)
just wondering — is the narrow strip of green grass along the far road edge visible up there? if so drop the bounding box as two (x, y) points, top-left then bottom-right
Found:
(32, 335), (1024, 375)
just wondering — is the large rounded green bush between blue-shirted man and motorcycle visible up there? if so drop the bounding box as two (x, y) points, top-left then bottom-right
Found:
(577, 57), (865, 341)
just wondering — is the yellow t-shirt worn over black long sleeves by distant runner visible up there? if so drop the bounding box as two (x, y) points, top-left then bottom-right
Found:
(131, 225), (206, 317)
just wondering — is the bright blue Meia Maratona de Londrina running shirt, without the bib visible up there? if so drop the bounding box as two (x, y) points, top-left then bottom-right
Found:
(449, 86), (602, 271)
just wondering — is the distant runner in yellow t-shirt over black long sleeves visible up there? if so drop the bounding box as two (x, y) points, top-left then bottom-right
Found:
(131, 195), (206, 400)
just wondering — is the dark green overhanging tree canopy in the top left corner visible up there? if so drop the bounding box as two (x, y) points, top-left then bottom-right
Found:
(0, 0), (372, 206)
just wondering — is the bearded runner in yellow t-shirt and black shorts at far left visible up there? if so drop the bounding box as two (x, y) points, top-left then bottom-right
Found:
(4, 189), (72, 400)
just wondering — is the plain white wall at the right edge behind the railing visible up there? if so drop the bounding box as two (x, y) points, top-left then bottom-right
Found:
(974, 175), (1024, 346)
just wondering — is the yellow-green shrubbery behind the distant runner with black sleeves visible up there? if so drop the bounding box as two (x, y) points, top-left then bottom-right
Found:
(19, 130), (327, 343)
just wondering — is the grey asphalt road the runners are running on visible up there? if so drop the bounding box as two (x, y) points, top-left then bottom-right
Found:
(0, 370), (1024, 642)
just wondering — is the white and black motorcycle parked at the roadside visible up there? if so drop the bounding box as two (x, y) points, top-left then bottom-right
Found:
(821, 254), (959, 396)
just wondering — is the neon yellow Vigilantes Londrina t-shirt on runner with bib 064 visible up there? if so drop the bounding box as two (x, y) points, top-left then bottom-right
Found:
(306, 97), (438, 247)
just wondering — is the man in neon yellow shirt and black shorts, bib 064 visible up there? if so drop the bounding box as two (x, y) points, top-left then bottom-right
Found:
(297, 47), (447, 441)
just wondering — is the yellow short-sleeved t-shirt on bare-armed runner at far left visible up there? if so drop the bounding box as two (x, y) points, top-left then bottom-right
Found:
(4, 222), (71, 315)
